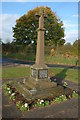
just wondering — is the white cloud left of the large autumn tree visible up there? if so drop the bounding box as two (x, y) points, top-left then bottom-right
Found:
(0, 14), (20, 42)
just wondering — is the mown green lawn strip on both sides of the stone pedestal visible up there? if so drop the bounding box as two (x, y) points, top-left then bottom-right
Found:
(2, 66), (78, 82)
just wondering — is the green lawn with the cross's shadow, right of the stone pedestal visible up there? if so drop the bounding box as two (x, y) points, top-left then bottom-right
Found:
(50, 68), (80, 83)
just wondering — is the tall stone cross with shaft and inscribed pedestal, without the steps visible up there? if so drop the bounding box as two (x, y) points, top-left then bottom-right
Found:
(31, 8), (48, 80)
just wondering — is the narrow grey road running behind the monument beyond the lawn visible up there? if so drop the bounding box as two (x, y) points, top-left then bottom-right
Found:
(2, 58), (80, 69)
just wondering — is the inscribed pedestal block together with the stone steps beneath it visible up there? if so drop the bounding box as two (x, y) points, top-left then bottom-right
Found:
(10, 65), (58, 99)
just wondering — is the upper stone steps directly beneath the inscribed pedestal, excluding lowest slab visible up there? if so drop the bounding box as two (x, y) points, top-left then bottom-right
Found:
(14, 77), (57, 98)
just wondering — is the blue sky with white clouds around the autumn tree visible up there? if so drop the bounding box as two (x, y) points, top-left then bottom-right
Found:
(0, 0), (78, 44)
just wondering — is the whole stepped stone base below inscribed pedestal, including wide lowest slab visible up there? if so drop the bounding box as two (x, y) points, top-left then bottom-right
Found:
(6, 77), (67, 101)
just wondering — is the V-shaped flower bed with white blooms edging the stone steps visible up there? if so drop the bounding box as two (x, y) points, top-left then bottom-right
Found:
(3, 83), (78, 112)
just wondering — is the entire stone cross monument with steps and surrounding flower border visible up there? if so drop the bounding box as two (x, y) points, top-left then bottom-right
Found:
(3, 6), (77, 118)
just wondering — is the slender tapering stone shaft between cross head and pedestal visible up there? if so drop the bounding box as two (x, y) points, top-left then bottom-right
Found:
(36, 15), (44, 67)
